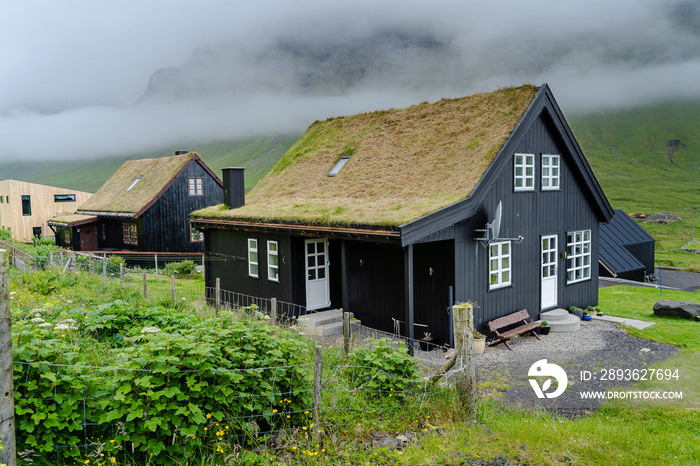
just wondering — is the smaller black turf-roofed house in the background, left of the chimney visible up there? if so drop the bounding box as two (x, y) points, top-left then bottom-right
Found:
(49, 151), (223, 252)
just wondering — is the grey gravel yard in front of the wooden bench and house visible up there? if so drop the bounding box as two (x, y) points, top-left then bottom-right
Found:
(416, 320), (678, 417)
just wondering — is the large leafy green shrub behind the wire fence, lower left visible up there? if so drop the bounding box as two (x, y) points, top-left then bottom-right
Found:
(13, 302), (311, 464)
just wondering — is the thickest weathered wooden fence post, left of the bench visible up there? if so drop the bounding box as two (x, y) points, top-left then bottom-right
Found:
(452, 303), (477, 418)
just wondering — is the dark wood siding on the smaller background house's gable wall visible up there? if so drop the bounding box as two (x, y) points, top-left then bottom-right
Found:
(145, 162), (224, 252)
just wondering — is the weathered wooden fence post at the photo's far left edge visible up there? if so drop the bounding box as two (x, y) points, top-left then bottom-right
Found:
(0, 249), (17, 466)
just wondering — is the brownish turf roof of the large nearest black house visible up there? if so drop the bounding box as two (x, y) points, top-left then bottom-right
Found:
(194, 85), (538, 226)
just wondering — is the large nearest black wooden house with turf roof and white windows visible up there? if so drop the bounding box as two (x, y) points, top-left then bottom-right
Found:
(191, 85), (612, 341)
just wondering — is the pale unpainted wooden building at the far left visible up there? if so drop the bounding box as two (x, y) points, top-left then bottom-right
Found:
(0, 180), (92, 242)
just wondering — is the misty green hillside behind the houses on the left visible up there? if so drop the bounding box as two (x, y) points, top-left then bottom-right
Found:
(0, 134), (300, 192)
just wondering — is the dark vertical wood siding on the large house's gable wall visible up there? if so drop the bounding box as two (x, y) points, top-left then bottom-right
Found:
(455, 114), (598, 330)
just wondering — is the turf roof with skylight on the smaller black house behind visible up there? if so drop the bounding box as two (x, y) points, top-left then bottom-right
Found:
(76, 152), (199, 216)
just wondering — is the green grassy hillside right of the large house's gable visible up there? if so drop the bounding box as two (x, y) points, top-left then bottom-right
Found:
(568, 101), (700, 271)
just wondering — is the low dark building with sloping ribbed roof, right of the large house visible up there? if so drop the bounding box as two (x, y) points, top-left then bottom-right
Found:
(599, 209), (656, 282)
